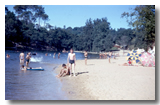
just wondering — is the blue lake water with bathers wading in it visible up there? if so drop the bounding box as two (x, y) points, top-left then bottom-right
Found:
(5, 50), (99, 100)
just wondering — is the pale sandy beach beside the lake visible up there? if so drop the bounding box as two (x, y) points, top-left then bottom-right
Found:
(55, 50), (155, 100)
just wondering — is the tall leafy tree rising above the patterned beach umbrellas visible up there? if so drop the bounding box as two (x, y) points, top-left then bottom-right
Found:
(121, 5), (155, 51)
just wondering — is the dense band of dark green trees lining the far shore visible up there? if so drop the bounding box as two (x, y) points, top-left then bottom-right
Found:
(5, 5), (155, 52)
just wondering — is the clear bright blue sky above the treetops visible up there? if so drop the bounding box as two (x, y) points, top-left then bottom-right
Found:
(5, 5), (136, 30)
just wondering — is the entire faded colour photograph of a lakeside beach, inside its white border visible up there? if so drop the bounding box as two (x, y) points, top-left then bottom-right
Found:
(5, 5), (155, 100)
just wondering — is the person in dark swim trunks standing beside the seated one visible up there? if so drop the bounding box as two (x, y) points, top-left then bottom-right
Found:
(67, 49), (76, 77)
